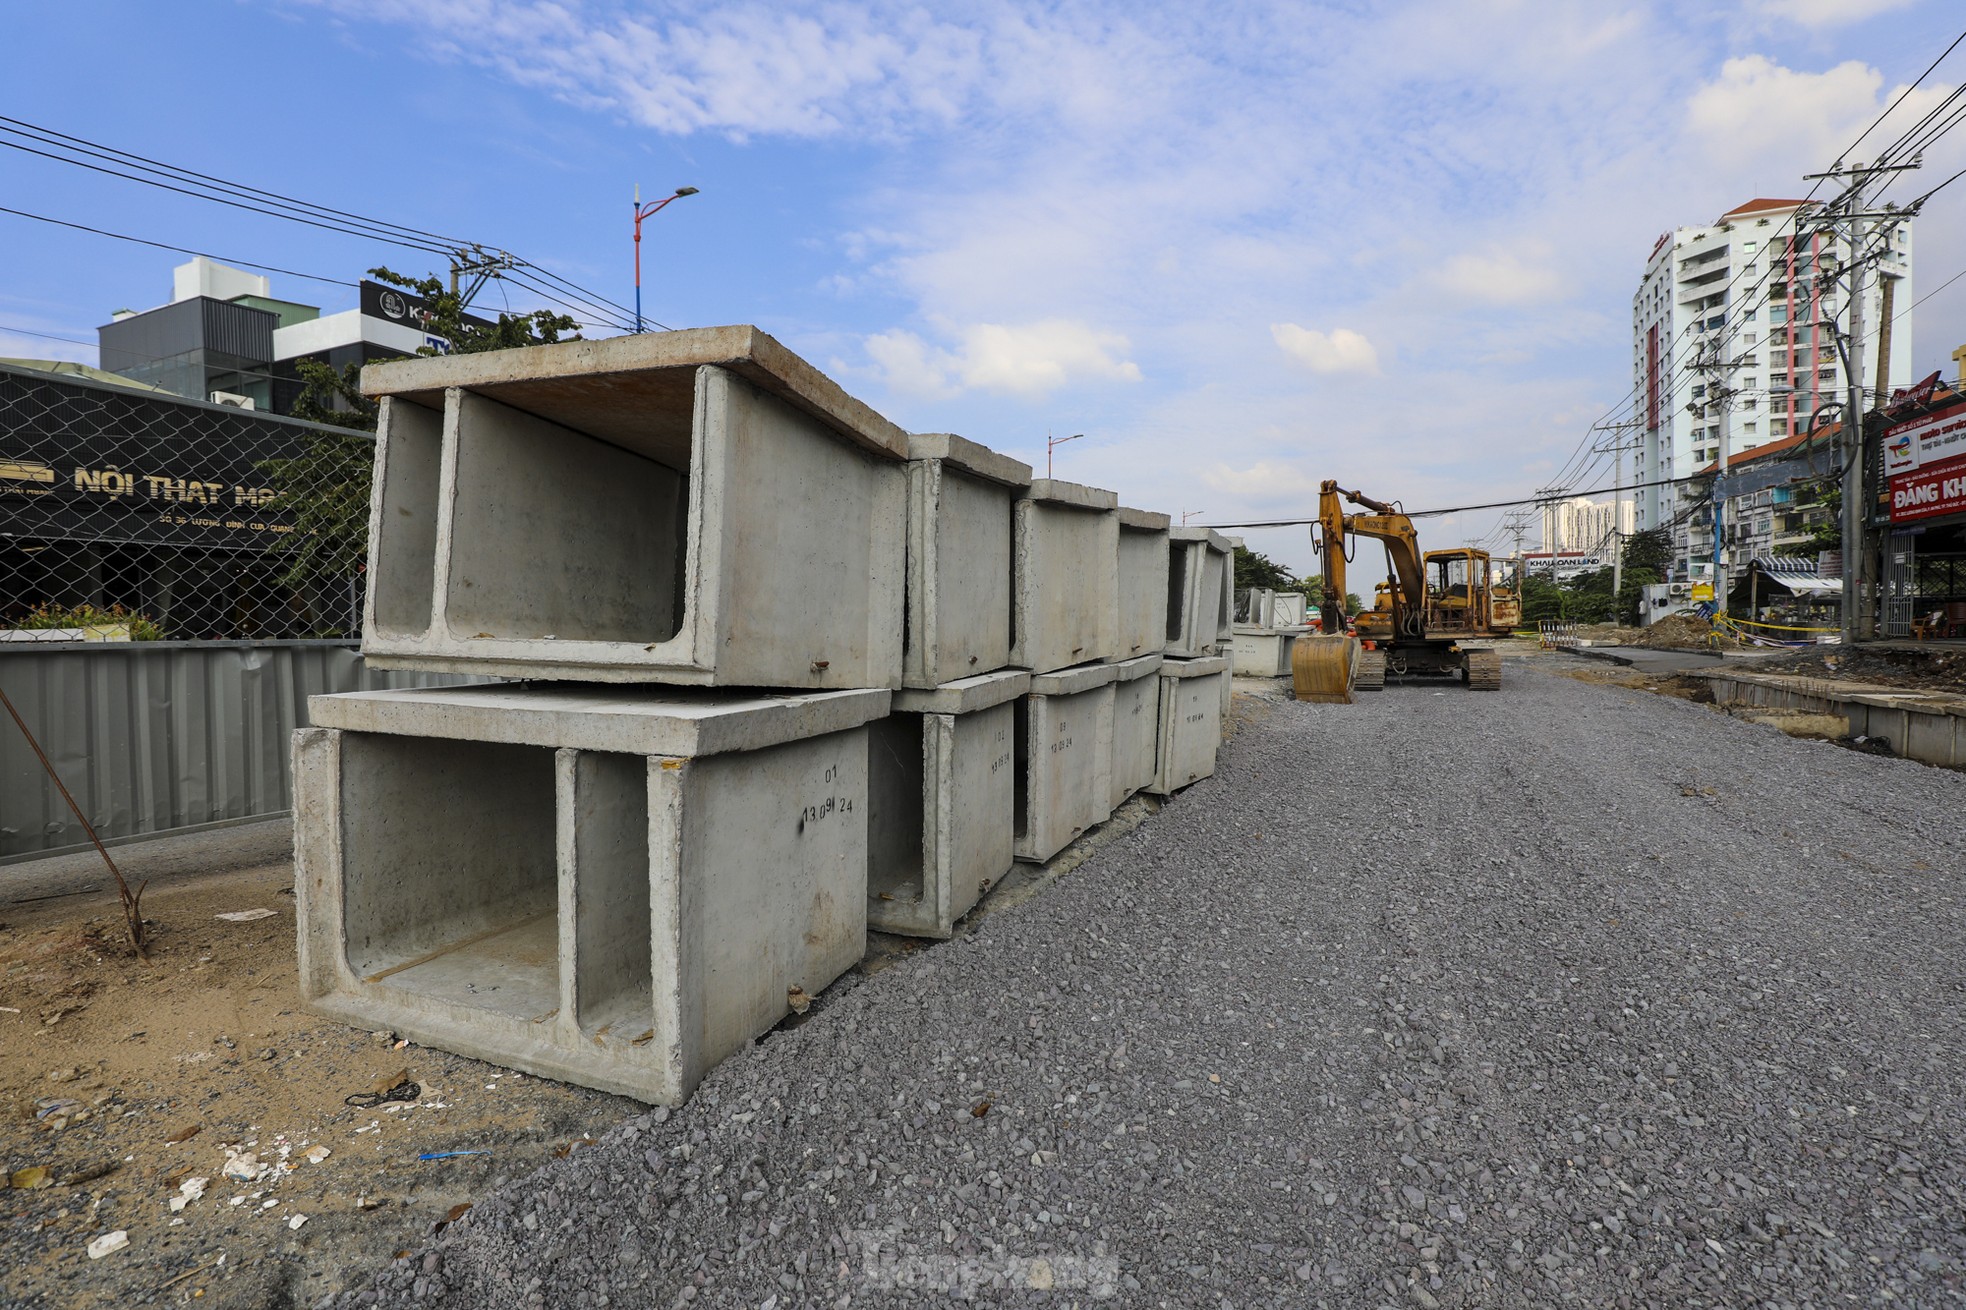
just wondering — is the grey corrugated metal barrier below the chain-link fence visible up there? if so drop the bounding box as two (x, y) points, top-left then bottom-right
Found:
(0, 641), (472, 863)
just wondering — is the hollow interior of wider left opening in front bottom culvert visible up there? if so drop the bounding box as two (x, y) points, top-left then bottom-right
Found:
(342, 732), (560, 1019)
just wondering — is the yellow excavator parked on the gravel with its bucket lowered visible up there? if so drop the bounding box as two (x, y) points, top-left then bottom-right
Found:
(1290, 480), (1522, 704)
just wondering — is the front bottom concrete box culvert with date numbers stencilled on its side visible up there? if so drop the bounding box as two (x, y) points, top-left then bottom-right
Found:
(293, 685), (889, 1105)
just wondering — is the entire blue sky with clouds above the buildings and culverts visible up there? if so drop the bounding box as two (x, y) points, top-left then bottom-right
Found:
(0, 0), (1966, 570)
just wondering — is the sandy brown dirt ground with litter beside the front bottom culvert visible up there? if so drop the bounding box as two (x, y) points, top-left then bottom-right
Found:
(0, 863), (643, 1308)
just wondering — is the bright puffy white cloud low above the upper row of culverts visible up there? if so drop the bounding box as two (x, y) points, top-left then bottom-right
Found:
(867, 319), (1140, 399)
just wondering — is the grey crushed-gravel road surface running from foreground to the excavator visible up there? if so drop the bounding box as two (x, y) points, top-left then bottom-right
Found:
(334, 661), (1966, 1310)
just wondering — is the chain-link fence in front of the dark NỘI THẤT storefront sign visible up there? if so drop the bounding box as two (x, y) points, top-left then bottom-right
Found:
(0, 366), (374, 641)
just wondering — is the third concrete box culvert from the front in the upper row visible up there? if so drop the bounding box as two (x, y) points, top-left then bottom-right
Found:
(1011, 478), (1119, 673)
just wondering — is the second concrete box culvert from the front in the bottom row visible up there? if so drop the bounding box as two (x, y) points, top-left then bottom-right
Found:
(867, 669), (1030, 938)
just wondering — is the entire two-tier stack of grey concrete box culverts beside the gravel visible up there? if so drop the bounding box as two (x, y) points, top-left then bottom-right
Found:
(295, 327), (1233, 1103)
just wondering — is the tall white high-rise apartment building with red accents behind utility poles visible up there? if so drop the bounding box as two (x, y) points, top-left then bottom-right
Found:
(1630, 201), (1915, 578)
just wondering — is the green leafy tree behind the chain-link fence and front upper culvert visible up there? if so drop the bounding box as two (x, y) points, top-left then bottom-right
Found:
(260, 268), (580, 613)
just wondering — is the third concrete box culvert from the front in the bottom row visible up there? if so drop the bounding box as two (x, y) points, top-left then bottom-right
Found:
(1012, 665), (1119, 863)
